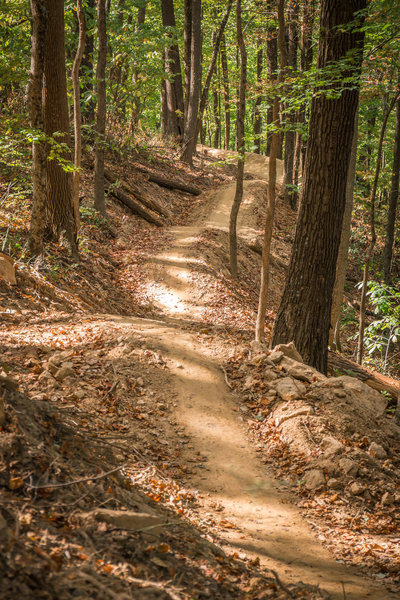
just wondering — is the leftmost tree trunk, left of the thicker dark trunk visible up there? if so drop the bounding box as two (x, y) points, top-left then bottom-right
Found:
(28, 0), (47, 256)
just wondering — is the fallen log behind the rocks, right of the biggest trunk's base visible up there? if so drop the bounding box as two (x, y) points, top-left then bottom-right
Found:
(328, 351), (400, 400)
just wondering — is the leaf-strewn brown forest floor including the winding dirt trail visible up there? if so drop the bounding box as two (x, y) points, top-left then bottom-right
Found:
(0, 143), (400, 600)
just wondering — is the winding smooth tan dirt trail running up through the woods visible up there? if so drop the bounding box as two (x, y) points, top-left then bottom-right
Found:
(118, 155), (395, 600)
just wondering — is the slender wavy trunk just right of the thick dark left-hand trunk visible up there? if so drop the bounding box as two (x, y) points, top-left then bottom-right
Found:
(71, 0), (86, 234)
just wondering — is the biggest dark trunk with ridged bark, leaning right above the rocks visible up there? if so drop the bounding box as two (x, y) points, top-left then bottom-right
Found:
(273, 0), (367, 373)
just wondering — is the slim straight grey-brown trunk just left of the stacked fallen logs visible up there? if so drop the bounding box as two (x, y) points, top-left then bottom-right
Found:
(94, 0), (107, 215)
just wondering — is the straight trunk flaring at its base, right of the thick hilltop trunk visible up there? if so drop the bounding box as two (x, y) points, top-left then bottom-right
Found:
(181, 0), (201, 165)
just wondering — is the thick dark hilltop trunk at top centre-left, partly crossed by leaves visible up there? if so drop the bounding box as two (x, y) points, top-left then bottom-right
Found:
(161, 0), (184, 139)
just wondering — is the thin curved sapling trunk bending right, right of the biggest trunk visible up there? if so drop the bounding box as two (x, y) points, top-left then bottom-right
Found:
(357, 91), (400, 365)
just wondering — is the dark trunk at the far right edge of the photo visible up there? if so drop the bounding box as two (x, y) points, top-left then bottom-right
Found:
(383, 70), (400, 285)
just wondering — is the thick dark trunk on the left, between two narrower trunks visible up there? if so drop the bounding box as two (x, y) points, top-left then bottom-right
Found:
(43, 0), (76, 252)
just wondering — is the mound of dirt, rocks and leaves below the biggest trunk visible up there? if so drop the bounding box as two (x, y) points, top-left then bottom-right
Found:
(227, 343), (400, 590)
